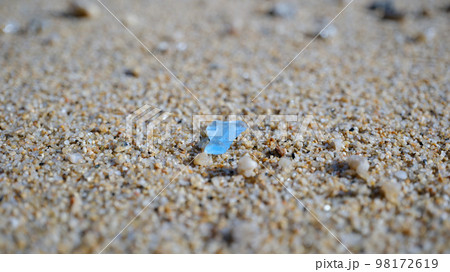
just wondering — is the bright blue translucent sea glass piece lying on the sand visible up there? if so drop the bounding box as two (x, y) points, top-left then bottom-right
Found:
(205, 121), (247, 155)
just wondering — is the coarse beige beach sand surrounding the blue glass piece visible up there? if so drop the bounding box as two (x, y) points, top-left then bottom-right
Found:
(0, 0), (450, 253)
